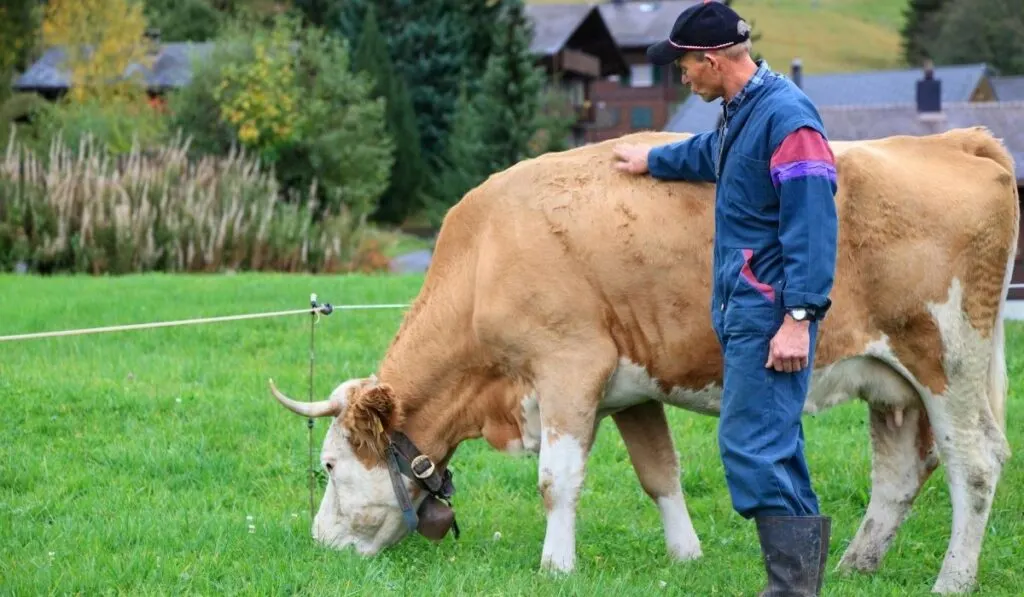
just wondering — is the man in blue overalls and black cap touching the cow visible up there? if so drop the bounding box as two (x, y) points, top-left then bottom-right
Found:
(614, 1), (838, 595)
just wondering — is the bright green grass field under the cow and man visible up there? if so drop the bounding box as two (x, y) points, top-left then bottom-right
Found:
(0, 274), (1024, 597)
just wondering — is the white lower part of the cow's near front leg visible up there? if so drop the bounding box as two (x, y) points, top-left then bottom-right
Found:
(539, 428), (585, 572)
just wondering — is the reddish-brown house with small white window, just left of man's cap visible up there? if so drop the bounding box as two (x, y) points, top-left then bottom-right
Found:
(587, 0), (701, 142)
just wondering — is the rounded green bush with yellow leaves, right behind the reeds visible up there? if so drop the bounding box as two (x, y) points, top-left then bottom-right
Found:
(169, 16), (393, 217)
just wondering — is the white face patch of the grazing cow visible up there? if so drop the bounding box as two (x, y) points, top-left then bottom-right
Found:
(312, 380), (425, 555)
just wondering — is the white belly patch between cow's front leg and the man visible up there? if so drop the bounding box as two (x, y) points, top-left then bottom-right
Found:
(598, 358), (722, 417)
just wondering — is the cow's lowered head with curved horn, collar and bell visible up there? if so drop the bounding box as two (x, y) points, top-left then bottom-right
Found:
(270, 377), (458, 555)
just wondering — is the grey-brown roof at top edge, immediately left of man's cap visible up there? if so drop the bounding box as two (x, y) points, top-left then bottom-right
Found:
(598, 0), (700, 49)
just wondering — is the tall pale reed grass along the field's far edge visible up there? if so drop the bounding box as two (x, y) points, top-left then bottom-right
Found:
(0, 132), (380, 274)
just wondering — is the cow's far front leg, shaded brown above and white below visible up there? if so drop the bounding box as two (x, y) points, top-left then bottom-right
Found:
(612, 400), (701, 560)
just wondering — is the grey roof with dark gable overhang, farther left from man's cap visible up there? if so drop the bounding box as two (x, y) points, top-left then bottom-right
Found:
(525, 4), (629, 76)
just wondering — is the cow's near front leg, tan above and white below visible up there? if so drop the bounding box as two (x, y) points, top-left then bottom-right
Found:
(535, 341), (615, 572)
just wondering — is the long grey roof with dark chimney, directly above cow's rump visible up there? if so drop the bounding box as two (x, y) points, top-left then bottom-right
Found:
(818, 100), (1024, 182)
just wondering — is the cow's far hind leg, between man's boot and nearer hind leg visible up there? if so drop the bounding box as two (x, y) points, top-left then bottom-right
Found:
(839, 407), (939, 572)
